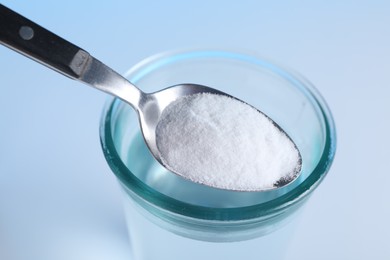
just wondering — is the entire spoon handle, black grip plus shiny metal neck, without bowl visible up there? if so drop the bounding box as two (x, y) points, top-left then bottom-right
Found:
(0, 4), (143, 109)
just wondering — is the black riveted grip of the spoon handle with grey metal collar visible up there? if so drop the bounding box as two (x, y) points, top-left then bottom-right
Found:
(0, 4), (90, 79)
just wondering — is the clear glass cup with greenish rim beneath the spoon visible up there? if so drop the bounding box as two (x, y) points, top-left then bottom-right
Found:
(100, 50), (336, 260)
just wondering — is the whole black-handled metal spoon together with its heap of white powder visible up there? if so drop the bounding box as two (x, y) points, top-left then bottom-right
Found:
(0, 4), (300, 190)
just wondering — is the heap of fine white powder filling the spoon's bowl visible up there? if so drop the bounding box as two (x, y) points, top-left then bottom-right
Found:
(156, 94), (301, 191)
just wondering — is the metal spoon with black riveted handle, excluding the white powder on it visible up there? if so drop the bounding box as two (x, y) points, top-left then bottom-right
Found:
(0, 4), (301, 191)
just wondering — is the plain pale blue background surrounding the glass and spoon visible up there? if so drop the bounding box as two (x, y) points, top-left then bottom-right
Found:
(0, 0), (390, 260)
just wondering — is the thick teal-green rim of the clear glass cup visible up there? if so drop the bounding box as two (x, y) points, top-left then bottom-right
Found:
(100, 50), (336, 221)
